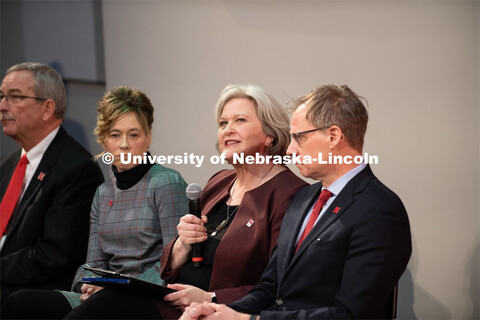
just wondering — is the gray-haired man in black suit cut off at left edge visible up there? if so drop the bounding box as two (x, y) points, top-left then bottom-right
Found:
(0, 62), (103, 302)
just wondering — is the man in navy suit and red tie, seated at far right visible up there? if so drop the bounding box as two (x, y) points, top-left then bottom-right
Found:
(183, 85), (411, 320)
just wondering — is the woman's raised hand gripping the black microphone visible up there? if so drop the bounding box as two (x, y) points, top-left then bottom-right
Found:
(170, 214), (208, 269)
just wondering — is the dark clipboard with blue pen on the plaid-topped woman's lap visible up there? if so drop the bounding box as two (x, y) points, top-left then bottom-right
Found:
(80, 265), (176, 298)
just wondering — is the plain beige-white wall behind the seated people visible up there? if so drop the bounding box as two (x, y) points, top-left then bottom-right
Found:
(103, 0), (480, 319)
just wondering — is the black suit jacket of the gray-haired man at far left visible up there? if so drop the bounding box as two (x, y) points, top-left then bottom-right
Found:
(0, 127), (103, 298)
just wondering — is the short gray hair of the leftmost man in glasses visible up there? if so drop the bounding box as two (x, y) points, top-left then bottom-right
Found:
(6, 62), (67, 119)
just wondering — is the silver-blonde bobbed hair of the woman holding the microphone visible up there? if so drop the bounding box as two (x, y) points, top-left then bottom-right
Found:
(215, 84), (290, 156)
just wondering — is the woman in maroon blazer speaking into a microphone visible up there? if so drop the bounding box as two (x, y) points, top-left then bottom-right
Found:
(65, 85), (306, 319)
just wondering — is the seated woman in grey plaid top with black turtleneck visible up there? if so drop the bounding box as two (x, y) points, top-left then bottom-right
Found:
(3, 87), (188, 319)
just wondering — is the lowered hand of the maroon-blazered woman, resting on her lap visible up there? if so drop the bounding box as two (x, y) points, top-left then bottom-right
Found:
(163, 283), (213, 311)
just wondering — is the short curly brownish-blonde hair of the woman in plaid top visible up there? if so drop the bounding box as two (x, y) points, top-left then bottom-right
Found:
(93, 87), (153, 146)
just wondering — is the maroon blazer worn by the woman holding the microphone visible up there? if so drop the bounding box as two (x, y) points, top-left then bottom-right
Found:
(161, 169), (307, 303)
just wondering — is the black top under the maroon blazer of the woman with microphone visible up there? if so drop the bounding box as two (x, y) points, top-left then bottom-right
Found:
(178, 202), (238, 291)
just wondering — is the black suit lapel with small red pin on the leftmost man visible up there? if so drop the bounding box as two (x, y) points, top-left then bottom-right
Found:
(7, 127), (67, 235)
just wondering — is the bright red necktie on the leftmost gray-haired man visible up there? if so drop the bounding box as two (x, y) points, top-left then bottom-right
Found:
(0, 154), (28, 234)
